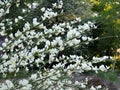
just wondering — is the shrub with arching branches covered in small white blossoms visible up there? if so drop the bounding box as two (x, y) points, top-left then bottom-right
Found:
(0, 0), (112, 90)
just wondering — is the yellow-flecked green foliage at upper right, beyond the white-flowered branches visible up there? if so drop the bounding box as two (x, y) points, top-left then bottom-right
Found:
(89, 0), (120, 56)
